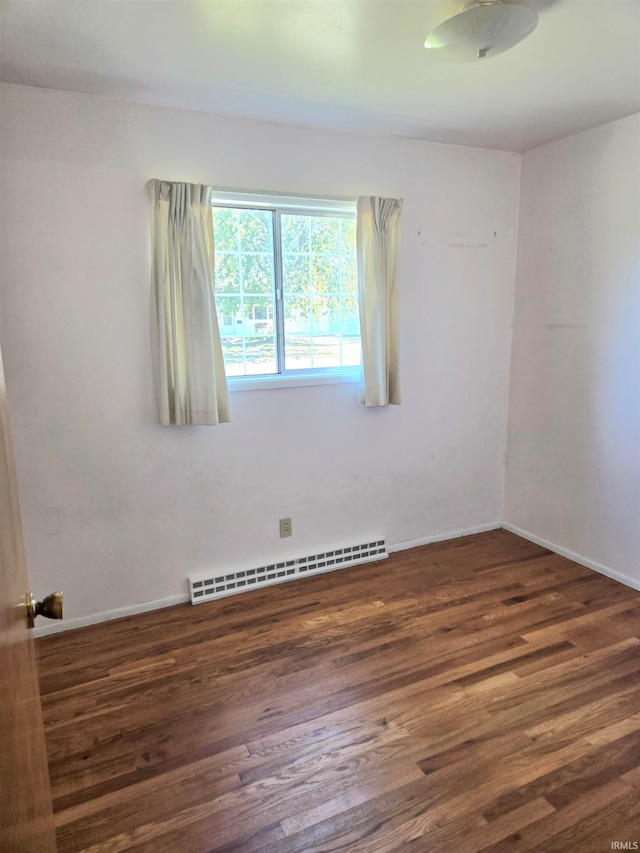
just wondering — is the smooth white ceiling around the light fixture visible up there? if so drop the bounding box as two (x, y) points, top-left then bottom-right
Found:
(0, 0), (640, 151)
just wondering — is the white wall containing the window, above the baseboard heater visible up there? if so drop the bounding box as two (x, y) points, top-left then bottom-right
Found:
(0, 85), (520, 618)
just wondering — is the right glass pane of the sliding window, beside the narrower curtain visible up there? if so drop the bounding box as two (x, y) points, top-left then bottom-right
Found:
(281, 214), (360, 370)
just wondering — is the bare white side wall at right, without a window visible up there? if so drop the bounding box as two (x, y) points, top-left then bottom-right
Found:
(505, 116), (640, 588)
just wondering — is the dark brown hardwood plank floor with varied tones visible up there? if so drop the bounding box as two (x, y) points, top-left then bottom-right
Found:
(37, 530), (640, 853)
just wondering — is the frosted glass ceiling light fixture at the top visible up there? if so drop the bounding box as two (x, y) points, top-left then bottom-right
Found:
(424, 0), (538, 62)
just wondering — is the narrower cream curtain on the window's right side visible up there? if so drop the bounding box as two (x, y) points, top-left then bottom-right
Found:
(356, 196), (402, 406)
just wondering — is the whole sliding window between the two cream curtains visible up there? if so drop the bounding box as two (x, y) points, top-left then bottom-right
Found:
(213, 192), (360, 380)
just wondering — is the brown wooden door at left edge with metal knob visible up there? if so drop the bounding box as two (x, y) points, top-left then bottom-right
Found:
(0, 342), (56, 853)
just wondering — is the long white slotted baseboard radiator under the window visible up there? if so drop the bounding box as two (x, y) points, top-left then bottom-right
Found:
(189, 536), (389, 604)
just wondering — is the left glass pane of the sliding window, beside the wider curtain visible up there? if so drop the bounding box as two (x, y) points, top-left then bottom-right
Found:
(213, 207), (278, 376)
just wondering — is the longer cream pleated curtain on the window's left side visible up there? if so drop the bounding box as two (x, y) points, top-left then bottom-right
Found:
(148, 180), (229, 425)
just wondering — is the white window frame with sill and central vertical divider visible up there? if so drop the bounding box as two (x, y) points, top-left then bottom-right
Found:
(211, 189), (362, 391)
